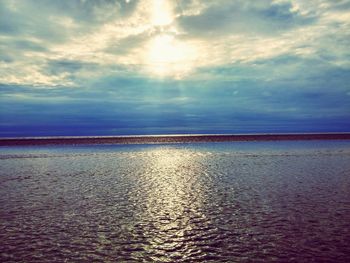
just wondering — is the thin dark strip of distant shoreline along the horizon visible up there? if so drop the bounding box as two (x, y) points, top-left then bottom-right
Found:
(0, 133), (350, 146)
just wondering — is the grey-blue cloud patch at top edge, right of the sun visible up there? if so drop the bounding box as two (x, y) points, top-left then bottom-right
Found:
(178, 0), (315, 36)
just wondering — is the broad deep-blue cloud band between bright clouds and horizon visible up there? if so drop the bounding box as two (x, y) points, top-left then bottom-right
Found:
(0, 56), (350, 136)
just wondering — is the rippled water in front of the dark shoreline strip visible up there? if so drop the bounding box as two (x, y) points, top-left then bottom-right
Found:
(0, 141), (350, 262)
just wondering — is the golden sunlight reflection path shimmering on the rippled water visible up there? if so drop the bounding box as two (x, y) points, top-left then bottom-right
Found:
(128, 148), (209, 262)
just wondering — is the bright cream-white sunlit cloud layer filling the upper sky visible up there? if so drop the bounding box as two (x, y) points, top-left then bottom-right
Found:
(0, 0), (350, 86)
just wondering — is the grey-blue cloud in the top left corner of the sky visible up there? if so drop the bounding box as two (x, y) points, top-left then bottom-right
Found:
(0, 0), (138, 42)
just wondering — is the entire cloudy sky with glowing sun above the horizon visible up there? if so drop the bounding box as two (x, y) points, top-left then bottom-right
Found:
(0, 0), (350, 137)
